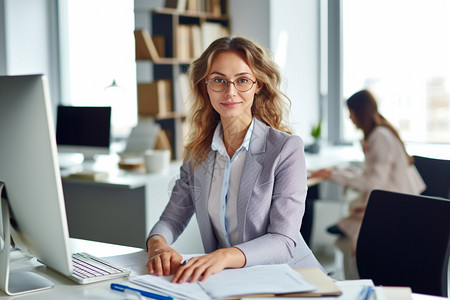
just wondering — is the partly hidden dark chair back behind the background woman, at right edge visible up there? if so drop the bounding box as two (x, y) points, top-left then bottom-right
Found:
(413, 156), (450, 199)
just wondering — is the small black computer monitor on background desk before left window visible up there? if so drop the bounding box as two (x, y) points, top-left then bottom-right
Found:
(56, 106), (111, 160)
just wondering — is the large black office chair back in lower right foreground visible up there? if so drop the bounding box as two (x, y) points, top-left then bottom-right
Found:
(356, 190), (450, 297)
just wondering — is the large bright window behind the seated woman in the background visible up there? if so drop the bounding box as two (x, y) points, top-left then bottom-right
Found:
(342, 0), (450, 143)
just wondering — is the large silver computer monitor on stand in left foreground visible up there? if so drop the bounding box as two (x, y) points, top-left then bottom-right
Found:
(0, 75), (72, 294)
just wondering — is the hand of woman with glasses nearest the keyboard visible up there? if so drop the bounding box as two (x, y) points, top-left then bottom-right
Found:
(147, 235), (183, 276)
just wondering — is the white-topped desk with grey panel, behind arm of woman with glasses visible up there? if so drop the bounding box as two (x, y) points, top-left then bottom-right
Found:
(62, 157), (203, 253)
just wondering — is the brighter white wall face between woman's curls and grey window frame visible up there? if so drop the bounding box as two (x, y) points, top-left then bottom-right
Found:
(270, 0), (319, 143)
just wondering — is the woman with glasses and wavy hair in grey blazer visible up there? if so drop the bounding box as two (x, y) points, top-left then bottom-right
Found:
(147, 37), (321, 283)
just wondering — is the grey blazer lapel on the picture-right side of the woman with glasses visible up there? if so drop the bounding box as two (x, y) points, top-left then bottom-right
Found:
(237, 118), (268, 243)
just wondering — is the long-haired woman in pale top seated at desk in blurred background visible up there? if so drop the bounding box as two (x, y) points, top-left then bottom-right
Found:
(310, 90), (425, 279)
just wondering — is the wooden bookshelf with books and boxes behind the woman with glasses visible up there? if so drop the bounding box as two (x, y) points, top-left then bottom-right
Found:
(134, 0), (230, 159)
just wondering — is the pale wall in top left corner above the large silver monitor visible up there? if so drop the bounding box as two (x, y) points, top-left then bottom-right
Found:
(0, 0), (59, 111)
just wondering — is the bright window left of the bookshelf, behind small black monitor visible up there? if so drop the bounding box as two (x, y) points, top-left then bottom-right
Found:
(59, 0), (137, 137)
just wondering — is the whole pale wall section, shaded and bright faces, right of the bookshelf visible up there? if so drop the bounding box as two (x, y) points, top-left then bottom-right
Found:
(229, 0), (319, 143)
